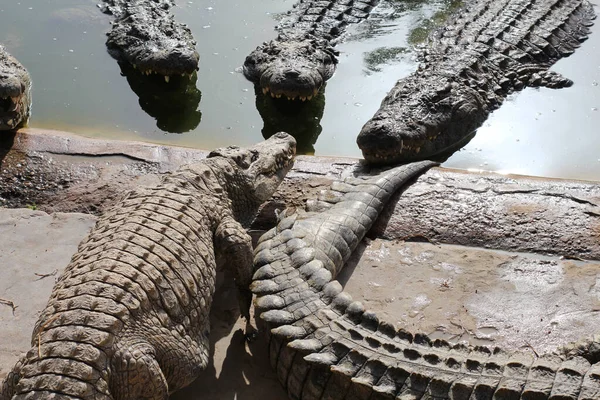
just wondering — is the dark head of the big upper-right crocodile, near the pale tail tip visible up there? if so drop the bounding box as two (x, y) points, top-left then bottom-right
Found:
(357, 77), (488, 164)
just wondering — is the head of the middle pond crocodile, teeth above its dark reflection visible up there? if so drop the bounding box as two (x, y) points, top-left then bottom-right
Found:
(244, 34), (338, 101)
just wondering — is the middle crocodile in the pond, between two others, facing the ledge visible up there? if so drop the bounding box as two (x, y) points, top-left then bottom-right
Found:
(243, 0), (379, 101)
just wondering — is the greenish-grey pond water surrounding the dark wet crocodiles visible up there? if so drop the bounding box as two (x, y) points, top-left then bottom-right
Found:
(0, 0), (600, 180)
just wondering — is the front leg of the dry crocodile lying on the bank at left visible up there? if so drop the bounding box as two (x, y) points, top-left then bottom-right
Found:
(215, 217), (253, 321)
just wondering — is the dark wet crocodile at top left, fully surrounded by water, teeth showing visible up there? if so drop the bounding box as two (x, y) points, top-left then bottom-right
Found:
(101, 0), (200, 82)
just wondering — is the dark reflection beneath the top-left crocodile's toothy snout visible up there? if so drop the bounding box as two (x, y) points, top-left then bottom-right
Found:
(119, 63), (202, 133)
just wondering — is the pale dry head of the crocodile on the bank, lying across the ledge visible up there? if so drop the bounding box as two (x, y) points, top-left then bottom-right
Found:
(208, 132), (296, 208)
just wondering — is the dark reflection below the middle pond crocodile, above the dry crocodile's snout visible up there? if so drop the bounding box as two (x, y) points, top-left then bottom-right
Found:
(254, 85), (325, 154)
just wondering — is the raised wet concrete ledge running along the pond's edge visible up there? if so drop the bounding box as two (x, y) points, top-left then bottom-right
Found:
(0, 129), (600, 260)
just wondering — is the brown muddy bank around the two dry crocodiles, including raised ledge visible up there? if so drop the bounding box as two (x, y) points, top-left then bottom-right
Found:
(0, 130), (600, 399)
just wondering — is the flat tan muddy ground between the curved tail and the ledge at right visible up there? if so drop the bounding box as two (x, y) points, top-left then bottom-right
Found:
(340, 239), (600, 354)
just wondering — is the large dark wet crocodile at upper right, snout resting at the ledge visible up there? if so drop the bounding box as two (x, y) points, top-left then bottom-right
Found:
(357, 0), (595, 164)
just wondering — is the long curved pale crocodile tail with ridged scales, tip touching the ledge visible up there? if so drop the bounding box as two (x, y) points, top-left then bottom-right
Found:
(251, 161), (600, 400)
